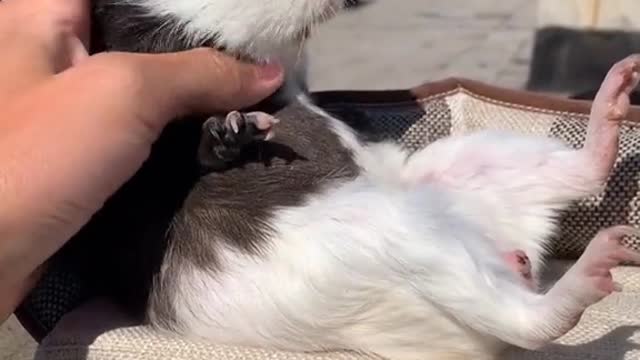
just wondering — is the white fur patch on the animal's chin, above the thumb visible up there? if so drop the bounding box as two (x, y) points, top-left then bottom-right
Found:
(130, 0), (343, 61)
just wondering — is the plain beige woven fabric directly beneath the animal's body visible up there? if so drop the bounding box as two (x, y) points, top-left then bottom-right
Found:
(36, 261), (640, 360)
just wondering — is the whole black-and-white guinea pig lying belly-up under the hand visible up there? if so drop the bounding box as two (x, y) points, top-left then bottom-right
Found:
(52, 0), (640, 360)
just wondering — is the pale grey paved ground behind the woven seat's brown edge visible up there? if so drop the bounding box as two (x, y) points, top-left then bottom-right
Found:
(0, 0), (536, 360)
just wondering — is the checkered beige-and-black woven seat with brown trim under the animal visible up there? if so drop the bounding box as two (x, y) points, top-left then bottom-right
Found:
(16, 78), (640, 360)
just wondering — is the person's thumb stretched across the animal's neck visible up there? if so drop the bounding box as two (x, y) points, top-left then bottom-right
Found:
(111, 48), (284, 121)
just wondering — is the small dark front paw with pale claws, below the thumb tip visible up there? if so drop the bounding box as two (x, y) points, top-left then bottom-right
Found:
(198, 111), (278, 171)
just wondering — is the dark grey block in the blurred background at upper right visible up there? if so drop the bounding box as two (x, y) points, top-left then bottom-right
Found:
(526, 27), (640, 97)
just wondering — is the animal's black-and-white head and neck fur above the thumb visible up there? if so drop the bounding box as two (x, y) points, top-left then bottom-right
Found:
(93, 0), (345, 98)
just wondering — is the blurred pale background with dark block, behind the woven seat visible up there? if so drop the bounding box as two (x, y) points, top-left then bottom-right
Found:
(0, 0), (640, 360)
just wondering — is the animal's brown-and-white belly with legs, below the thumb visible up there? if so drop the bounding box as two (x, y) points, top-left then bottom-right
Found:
(139, 55), (640, 360)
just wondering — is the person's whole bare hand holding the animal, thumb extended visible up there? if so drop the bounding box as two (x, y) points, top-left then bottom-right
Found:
(0, 0), (283, 322)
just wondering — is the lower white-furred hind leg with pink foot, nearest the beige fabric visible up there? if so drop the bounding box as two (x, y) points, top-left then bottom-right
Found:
(428, 226), (640, 350)
